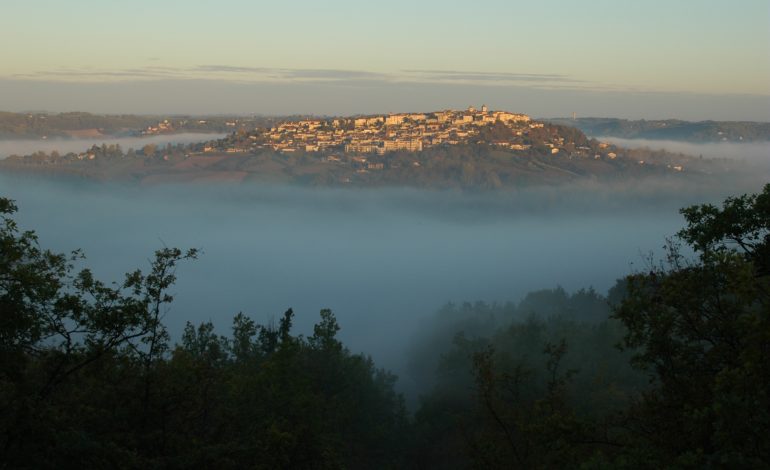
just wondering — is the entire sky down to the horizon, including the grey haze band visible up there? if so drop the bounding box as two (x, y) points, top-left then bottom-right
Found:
(0, 0), (770, 121)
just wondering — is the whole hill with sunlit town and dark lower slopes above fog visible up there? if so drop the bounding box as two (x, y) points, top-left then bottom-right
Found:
(0, 106), (720, 188)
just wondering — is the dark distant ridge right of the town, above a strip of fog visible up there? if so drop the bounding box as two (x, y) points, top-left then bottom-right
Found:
(545, 118), (770, 143)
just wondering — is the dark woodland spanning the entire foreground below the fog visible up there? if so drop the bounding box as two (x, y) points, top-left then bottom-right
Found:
(0, 185), (770, 469)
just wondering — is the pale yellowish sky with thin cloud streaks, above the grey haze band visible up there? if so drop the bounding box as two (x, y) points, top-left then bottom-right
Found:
(0, 0), (770, 102)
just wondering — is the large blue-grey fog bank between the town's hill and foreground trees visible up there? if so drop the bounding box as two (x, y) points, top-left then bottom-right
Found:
(0, 175), (759, 386)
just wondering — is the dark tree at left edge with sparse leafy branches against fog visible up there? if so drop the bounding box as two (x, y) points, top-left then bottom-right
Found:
(0, 198), (196, 465)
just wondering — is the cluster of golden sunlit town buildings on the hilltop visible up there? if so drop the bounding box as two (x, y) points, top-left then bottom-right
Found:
(194, 105), (632, 164)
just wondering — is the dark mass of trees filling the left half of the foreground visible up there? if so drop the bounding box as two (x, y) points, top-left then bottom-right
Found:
(0, 199), (407, 468)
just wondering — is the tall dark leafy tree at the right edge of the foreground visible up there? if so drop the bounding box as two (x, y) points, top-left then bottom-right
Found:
(615, 185), (770, 468)
